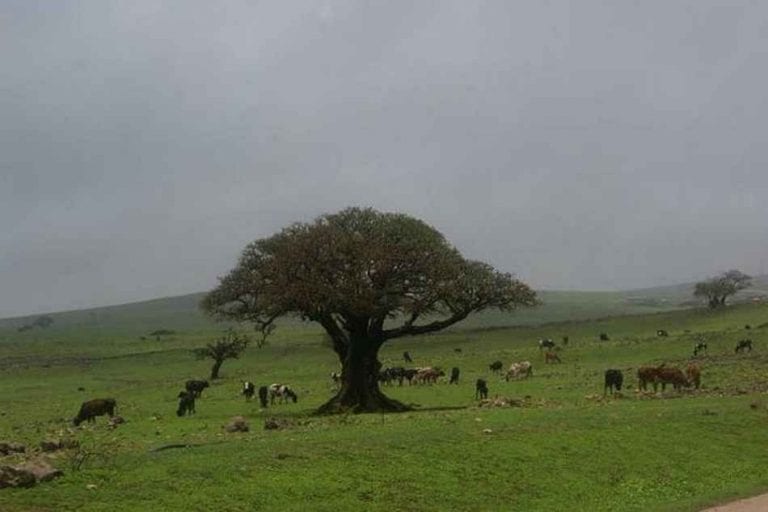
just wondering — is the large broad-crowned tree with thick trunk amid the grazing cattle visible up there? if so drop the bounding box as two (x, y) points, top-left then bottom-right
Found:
(202, 208), (538, 413)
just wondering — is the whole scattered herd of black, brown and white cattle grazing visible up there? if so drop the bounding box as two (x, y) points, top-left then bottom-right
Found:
(73, 329), (752, 426)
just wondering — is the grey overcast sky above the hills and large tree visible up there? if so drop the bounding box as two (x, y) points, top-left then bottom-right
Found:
(0, 0), (768, 317)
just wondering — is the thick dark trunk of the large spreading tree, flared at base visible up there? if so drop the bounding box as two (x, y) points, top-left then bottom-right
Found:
(317, 340), (410, 414)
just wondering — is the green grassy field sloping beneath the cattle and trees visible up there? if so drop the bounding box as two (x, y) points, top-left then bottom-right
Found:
(0, 305), (768, 512)
